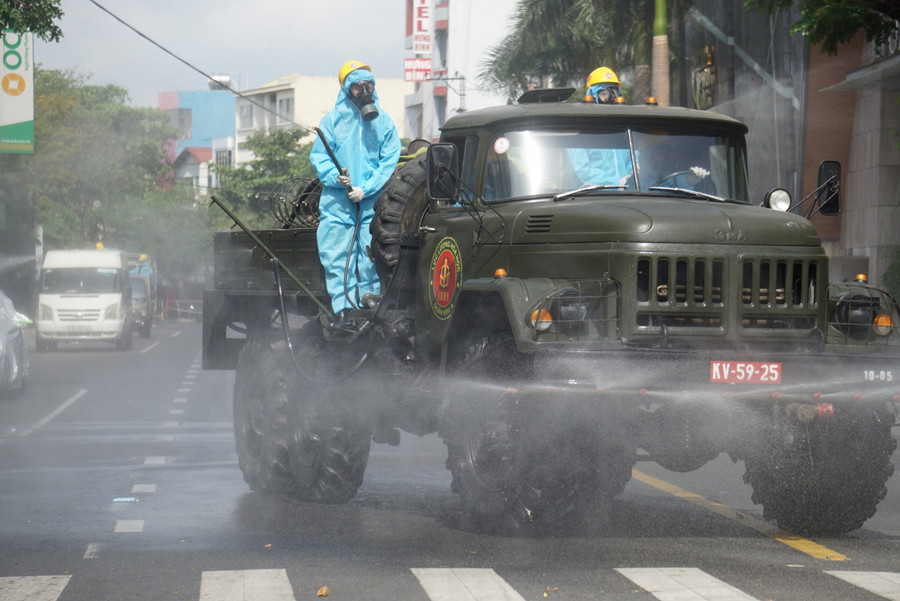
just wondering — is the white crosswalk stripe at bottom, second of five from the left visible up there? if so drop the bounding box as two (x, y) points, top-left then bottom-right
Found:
(199, 570), (296, 601)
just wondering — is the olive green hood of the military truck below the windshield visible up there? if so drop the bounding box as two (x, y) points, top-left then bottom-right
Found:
(502, 197), (820, 246)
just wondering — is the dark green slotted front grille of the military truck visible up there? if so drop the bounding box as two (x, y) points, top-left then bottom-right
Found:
(635, 256), (824, 335)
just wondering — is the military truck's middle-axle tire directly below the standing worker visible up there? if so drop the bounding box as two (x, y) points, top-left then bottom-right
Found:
(288, 323), (372, 503)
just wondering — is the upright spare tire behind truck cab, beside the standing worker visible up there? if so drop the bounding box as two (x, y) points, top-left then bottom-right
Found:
(370, 154), (428, 286)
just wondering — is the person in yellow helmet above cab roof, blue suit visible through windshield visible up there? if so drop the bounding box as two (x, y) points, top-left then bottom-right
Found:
(569, 67), (632, 186)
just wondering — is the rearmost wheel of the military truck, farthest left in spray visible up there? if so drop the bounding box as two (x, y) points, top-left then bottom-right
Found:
(234, 340), (294, 495)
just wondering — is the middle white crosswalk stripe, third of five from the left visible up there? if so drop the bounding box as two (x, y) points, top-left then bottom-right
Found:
(410, 568), (525, 601)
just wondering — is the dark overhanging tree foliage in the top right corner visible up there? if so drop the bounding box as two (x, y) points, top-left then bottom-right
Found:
(744, 0), (900, 55)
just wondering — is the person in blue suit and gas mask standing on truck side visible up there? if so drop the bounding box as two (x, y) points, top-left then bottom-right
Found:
(309, 61), (400, 326)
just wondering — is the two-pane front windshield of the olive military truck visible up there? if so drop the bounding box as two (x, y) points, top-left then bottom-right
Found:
(482, 128), (749, 202)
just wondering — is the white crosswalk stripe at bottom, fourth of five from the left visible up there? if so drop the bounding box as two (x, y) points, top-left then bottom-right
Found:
(616, 568), (756, 601)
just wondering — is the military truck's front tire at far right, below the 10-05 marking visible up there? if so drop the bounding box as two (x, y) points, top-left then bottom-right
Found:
(744, 407), (897, 536)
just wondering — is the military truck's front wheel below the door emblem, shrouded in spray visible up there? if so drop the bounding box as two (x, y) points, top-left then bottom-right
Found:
(440, 333), (574, 535)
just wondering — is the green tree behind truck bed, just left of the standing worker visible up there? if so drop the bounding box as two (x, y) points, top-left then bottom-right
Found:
(216, 129), (316, 227)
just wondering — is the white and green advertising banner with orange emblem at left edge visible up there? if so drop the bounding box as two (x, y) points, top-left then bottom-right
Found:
(0, 29), (34, 154)
